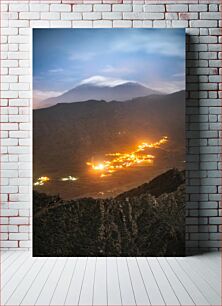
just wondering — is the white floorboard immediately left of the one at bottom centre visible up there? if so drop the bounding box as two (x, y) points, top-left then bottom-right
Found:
(93, 257), (107, 305)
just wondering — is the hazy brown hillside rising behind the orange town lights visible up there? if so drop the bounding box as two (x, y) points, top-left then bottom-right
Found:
(33, 91), (185, 189)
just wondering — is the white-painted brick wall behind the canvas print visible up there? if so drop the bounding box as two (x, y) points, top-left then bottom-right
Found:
(0, 0), (222, 252)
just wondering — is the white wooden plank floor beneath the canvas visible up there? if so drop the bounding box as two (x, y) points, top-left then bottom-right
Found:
(0, 251), (221, 306)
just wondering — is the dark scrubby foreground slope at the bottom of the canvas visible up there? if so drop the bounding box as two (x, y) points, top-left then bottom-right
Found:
(33, 169), (185, 256)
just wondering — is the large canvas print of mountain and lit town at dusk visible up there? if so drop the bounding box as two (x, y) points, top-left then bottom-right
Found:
(33, 29), (185, 256)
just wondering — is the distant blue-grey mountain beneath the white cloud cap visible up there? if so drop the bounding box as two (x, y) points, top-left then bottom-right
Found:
(36, 82), (160, 107)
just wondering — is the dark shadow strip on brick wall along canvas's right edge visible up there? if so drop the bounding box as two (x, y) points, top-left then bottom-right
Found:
(186, 35), (206, 255)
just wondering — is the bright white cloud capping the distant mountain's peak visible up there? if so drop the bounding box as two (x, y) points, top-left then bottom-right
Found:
(79, 75), (133, 87)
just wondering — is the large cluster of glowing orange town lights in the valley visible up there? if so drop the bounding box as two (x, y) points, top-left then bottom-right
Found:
(86, 136), (168, 177)
